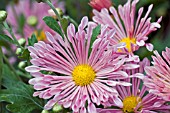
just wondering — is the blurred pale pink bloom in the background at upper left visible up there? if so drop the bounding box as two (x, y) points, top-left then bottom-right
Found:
(7, 0), (64, 41)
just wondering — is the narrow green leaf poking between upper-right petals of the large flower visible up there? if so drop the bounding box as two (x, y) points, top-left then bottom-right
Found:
(89, 25), (101, 55)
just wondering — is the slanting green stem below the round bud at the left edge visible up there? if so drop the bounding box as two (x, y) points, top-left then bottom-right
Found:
(3, 21), (24, 50)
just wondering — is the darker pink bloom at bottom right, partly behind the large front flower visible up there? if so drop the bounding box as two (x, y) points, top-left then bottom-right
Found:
(98, 59), (170, 113)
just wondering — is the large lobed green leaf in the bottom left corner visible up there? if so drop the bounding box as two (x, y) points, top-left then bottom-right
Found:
(0, 82), (43, 113)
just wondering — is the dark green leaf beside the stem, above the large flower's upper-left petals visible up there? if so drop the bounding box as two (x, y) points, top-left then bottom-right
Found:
(43, 16), (64, 38)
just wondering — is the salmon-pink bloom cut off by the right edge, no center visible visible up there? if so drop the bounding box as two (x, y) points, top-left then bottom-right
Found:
(144, 48), (170, 101)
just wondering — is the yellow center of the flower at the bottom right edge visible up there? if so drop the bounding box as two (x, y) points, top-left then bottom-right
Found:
(123, 96), (141, 113)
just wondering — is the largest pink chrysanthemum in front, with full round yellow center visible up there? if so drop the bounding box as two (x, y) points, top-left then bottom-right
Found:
(26, 17), (131, 113)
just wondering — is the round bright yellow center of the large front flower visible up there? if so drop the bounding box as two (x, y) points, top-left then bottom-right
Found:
(72, 64), (96, 86)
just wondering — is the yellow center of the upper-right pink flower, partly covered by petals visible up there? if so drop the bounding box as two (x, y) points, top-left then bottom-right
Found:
(118, 37), (136, 52)
